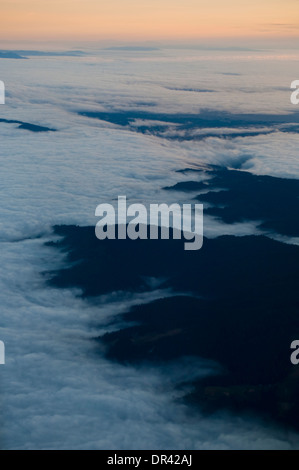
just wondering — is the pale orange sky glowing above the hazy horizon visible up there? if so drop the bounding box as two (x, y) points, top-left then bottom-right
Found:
(0, 0), (299, 40)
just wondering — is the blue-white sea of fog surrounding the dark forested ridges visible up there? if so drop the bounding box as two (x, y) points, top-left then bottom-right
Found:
(0, 47), (299, 449)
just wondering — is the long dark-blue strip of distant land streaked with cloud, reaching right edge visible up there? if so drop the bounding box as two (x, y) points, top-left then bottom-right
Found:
(78, 108), (299, 141)
